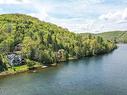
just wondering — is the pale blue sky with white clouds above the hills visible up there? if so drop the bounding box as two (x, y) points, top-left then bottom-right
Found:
(0, 0), (127, 33)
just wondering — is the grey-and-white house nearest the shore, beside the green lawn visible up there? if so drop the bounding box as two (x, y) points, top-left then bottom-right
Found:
(7, 53), (24, 66)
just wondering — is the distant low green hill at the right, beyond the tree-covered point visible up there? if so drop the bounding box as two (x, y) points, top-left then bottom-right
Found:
(97, 31), (127, 43)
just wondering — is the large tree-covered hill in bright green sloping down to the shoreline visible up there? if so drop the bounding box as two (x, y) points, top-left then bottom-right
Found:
(0, 14), (116, 71)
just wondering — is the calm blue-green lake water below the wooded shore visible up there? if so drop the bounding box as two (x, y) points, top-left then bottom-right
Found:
(0, 44), (127, 95)
